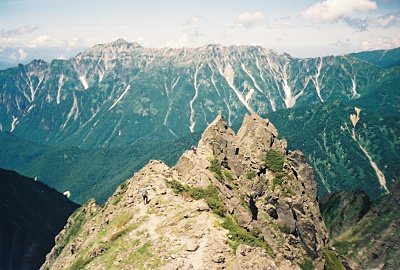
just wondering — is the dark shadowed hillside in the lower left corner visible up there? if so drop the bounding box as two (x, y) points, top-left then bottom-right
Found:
(0, 169), (78, 270)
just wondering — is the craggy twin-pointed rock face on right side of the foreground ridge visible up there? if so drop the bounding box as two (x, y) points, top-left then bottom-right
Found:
(176, 114), (328, 263)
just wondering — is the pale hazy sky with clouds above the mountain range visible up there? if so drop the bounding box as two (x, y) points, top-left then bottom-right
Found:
(0, 0), (400, 63)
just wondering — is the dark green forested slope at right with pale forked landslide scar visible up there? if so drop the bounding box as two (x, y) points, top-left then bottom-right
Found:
(270, 68), (400, 199)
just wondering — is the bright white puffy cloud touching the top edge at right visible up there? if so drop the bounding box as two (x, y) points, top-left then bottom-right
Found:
(302, 0), (378, 22)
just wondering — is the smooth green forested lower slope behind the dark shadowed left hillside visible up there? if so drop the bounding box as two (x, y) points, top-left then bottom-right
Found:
(0, 132), (200, 204)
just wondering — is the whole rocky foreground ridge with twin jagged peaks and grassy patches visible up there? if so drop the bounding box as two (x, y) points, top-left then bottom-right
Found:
(41, 114), (347, 269)
